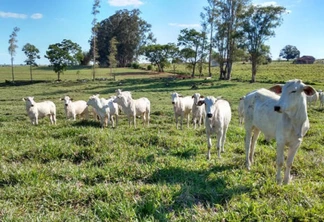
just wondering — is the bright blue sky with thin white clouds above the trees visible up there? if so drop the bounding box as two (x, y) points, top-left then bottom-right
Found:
(0, 0), (324, 65)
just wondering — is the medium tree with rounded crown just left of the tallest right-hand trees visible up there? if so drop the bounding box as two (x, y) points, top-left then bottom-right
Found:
(178, 29), (207, 77)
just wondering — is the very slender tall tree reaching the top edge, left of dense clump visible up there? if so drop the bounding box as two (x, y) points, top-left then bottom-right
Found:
(91, 0), (100, 81)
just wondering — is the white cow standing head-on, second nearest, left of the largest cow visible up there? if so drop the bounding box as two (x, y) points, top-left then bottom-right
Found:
(198, 96), (232, 160)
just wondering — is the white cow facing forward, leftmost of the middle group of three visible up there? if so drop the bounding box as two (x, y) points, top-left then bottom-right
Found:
(171, 92), (193, 129)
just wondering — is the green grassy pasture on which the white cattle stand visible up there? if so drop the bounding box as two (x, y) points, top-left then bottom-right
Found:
(0, 63), (324, 221)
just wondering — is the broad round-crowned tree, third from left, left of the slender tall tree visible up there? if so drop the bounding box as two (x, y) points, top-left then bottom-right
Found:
(45, 39), (83, 81)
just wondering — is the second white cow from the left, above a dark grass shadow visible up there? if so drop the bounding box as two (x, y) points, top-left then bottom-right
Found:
(61, 96), (89, 120)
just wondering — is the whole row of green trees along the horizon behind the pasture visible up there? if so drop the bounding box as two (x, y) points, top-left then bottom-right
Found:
(9, 0), (299, 82)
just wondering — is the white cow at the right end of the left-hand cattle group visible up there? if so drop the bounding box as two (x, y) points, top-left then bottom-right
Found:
(113, 94), (151, 128)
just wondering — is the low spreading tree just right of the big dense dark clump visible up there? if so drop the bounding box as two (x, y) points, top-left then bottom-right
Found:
(142, 43), (177, 72)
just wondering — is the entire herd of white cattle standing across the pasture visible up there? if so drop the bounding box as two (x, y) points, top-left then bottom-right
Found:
(23, 79), (324, 184)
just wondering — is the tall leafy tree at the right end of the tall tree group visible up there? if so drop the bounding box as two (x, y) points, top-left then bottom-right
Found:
(242, 5), (285, 82)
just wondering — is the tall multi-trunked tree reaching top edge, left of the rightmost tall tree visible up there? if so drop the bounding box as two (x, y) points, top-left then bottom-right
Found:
(213, 0), (250, 80)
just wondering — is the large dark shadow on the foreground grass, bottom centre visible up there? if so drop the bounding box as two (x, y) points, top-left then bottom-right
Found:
(140, 164), (251, 221)
